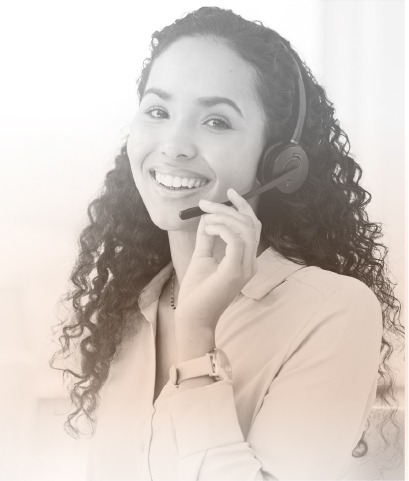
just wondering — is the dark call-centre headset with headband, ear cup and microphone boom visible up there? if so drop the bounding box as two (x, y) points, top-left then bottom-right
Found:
(179, 42), (309, 220)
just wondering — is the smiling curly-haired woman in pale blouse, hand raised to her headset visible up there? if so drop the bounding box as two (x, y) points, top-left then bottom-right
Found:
(53, 8), (401, 480)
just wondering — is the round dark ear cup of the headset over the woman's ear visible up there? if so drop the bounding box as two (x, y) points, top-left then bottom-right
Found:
(257, 144), (308, 194)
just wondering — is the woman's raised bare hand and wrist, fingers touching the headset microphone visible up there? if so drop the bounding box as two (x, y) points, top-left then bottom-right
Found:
(175, 189), (261, 358)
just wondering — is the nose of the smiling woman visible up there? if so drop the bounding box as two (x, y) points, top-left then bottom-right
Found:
(160, 125), (197, 160)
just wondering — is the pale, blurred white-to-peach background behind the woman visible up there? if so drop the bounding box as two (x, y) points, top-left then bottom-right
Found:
(0, 0), (406, 481)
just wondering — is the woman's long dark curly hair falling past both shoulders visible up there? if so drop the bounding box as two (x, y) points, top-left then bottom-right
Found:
(53, 7), (403, 455)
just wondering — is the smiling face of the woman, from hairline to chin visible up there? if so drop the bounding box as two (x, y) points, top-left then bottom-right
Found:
(127, 37), (265, 230)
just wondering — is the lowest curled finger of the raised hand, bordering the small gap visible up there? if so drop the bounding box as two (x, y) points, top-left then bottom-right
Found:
(205, 224), (245, 278)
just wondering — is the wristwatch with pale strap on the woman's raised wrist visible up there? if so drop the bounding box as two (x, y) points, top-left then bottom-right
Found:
(169, 349), (232, 386)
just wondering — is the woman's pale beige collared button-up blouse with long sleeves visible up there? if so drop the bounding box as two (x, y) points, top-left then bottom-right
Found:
(89, 248), (382, 481)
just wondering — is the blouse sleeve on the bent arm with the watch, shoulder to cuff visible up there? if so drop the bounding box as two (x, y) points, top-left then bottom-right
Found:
(159, 282), (382, 481)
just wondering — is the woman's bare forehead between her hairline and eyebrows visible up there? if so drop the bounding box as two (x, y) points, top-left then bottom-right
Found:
(146, 37), (258, 103)
